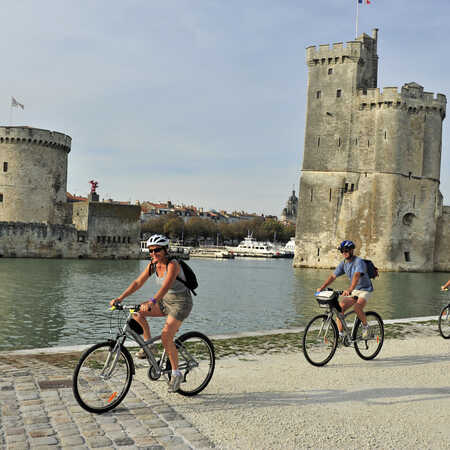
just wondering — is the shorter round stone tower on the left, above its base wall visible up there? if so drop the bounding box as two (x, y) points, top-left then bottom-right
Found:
(0, 127), (72, 224)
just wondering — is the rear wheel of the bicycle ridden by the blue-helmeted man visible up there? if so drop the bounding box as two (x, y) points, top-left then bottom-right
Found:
(352, 311), (384, 360)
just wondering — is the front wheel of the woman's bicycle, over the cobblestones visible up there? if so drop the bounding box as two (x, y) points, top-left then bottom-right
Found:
(72, 341), (134, 414)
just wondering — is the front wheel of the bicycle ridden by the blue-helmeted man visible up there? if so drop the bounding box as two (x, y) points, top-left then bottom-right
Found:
(302, 314), (338, 366)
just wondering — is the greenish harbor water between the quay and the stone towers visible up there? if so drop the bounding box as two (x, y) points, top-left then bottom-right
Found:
(0, 258), (449, 350)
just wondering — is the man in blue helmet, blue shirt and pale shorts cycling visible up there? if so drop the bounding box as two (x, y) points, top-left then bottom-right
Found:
(318, 240), (373, 339)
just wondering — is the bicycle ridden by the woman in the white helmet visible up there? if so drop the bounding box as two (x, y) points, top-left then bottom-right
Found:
(72, 304), (215, 414)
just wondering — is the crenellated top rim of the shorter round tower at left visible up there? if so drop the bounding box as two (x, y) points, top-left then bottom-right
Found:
(0, 126), (72, 153)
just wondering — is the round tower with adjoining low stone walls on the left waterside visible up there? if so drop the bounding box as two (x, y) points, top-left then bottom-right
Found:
(0, 127), (141, 258)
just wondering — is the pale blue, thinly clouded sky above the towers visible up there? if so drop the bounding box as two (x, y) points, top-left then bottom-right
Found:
(0, 0), (450, 215)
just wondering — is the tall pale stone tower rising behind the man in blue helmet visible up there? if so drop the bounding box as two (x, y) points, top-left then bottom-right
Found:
(294, 29), (446, 271)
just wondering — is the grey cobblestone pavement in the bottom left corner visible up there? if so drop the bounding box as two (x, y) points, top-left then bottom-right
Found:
(0, 353), (214, 450)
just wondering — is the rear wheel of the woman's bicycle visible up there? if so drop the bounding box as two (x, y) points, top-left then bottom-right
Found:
(175, 331), (216, 396)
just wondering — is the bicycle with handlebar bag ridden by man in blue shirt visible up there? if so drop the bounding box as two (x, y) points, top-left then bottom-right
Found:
(302, 289), (384, 367)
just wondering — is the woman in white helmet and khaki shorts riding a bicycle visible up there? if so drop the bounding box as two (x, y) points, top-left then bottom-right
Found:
(110, 234), (192, 392)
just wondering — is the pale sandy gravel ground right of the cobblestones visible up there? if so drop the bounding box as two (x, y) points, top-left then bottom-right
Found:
(138, 332), (450, 449)
